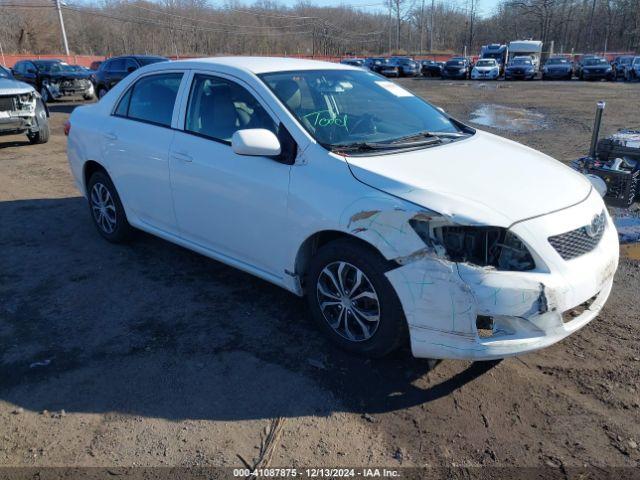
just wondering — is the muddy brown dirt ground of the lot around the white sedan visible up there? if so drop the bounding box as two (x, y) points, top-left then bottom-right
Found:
(0, 79), (640, 476)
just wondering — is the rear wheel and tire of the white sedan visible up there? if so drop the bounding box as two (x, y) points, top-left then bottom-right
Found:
(87, 171), (132, 243)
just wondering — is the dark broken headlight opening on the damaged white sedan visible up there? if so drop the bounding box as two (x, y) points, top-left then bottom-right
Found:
(409, 220), (536, 271)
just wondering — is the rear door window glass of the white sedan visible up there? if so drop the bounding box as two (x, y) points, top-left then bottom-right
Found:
(120, 73), (182, 127)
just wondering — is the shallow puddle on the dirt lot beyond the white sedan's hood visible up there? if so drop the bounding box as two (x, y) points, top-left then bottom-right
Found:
(471, 104), (549, 132)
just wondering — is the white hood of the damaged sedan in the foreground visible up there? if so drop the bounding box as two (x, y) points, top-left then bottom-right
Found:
(346, 131), (591, 227)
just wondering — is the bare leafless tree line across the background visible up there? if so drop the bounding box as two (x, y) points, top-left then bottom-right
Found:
(0, 0), (640, 56)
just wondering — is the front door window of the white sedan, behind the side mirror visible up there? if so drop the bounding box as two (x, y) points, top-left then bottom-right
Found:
(184, 75), (278, 143)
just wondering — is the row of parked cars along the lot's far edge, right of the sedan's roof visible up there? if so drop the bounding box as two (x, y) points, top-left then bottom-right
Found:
(341, 55), (640, 81)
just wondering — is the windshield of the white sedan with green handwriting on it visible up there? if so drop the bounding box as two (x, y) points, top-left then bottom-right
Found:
(260, 70), (461, 148)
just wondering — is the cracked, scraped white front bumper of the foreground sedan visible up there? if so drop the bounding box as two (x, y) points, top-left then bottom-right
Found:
(370, 189), (619, 360)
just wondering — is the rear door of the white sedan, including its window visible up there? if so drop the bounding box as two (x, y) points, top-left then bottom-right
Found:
(103, 71), (184, 233)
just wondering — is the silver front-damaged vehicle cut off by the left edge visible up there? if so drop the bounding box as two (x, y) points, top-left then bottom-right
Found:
(0, 65), (49, 143)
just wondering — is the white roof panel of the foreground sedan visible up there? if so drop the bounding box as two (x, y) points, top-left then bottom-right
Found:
(168, 57), (360, 75)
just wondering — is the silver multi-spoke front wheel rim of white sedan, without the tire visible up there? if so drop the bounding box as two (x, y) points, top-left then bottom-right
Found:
(316, 261), (380, 342)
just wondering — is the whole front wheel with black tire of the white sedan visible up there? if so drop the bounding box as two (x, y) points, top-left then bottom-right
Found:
(305, 239), (408, 357)
